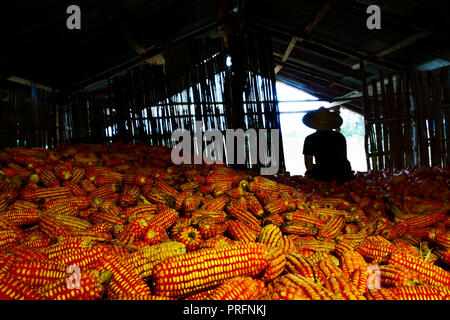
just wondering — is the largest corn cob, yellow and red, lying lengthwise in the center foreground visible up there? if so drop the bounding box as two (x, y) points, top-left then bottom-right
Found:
(153, 243), (268, 297)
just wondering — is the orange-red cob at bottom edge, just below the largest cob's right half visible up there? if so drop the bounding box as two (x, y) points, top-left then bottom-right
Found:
(208, 277), (264, 300)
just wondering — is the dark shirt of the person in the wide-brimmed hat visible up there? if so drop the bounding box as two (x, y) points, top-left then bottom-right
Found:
(303, 130), (353, 183)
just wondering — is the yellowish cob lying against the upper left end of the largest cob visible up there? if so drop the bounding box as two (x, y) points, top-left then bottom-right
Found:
(125, 241), (186, 279)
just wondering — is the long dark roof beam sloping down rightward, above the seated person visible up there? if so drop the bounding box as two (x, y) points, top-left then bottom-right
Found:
(252, 17), (404, 71)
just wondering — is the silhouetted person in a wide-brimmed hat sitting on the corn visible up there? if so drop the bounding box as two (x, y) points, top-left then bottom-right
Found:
(303, 107), (355, 183)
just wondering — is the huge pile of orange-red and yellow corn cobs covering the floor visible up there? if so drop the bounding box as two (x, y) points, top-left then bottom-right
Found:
(0, 143), (450, 300)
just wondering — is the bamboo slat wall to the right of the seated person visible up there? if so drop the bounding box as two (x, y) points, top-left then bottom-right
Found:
(363, 68), (450, 170)
